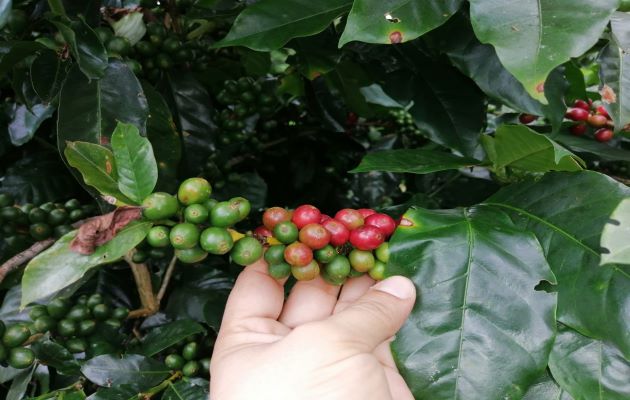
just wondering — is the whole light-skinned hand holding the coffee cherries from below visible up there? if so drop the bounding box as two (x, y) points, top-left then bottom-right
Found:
(210, 260), (416, 400)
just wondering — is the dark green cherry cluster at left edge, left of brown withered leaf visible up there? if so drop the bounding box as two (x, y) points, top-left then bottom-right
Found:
(0, 194), (96, 255)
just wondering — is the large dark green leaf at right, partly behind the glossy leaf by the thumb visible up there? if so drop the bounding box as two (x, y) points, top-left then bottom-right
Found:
(483, 171), (630, 357)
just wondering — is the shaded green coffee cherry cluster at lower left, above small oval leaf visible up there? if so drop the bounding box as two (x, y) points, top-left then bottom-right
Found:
(29, 293), (129, 358)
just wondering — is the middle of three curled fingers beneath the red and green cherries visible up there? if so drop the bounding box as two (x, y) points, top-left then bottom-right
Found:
(279, 276), (339, 328)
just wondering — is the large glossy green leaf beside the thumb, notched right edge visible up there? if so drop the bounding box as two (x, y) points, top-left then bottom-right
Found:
(387, 207), (556, 400)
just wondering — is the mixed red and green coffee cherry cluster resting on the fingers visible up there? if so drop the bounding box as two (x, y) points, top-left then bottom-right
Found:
(254, 204), (396, 285)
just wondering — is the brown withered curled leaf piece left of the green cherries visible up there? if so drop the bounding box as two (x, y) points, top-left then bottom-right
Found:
(70, 206), (142, 254)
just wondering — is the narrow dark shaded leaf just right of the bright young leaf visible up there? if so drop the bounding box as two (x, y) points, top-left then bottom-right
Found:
(142, 83), (182, 192)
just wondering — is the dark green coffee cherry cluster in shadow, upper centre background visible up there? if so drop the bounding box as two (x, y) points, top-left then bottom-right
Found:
(217, 77), (280, 145)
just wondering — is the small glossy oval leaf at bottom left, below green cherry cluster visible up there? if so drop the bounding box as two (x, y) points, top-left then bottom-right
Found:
(81, 354), (169, 390)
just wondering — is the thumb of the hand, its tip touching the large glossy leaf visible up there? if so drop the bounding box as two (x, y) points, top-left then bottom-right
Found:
(326, 276), (416, 351)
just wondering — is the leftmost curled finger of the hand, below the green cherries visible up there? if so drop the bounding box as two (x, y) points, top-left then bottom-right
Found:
(221, 259), (284, 330)
